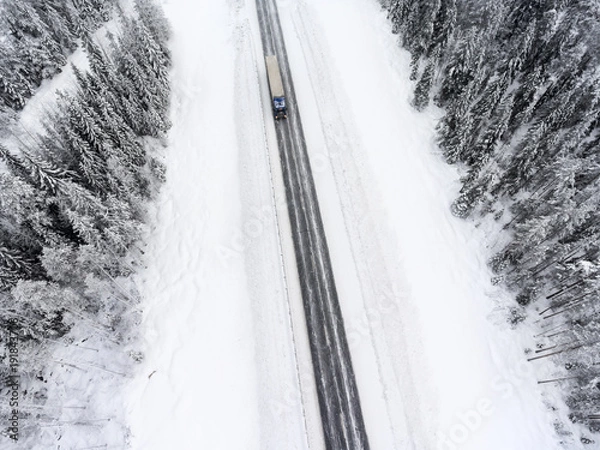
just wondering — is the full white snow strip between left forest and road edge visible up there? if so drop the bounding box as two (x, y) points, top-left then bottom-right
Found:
(128, 0), (314, 450)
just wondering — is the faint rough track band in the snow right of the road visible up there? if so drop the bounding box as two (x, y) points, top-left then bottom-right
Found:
(284, 5), (419, 450)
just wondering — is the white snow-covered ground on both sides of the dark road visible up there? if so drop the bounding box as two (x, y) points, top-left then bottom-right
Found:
(127, 0), (577, 450)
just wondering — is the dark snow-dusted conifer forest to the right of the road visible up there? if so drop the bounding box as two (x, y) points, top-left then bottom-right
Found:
(383, 0), (600, 432)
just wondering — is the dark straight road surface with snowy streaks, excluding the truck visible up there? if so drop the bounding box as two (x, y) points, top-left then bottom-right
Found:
(256, 0), (369, 450)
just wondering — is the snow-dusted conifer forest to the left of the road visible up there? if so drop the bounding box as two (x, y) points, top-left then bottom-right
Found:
(0, 0), (170, 442)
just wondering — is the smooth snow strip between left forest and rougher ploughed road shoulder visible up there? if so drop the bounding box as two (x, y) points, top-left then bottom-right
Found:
(124, 1), (258, 449)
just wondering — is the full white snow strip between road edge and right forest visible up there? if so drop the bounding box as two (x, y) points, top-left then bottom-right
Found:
(279, 0), (576, 450)
